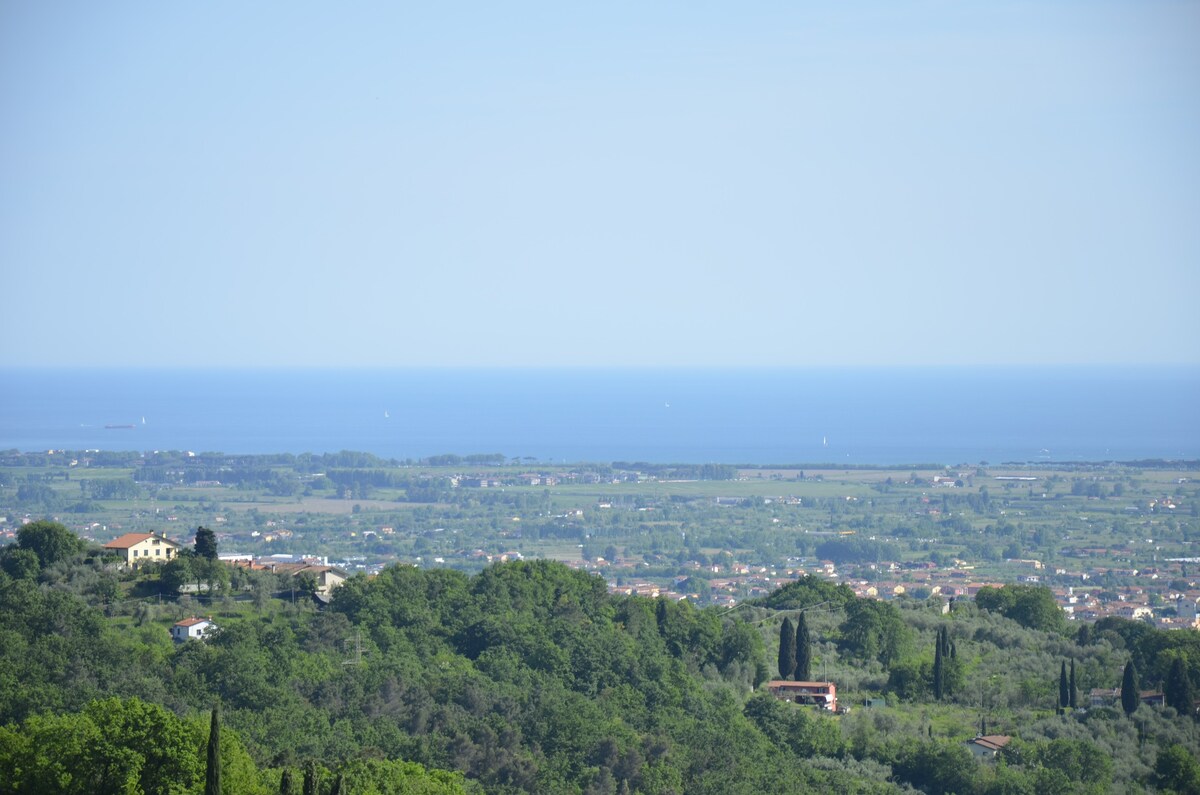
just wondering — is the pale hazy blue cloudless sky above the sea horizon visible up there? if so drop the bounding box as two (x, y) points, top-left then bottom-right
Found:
(0, 0), (1200, 365)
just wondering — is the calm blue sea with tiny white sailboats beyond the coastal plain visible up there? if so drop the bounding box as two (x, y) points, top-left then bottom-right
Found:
(0, 367), (1200, 466)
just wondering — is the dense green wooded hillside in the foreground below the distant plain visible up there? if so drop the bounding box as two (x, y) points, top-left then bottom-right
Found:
(0, 522), (1200, 795)
